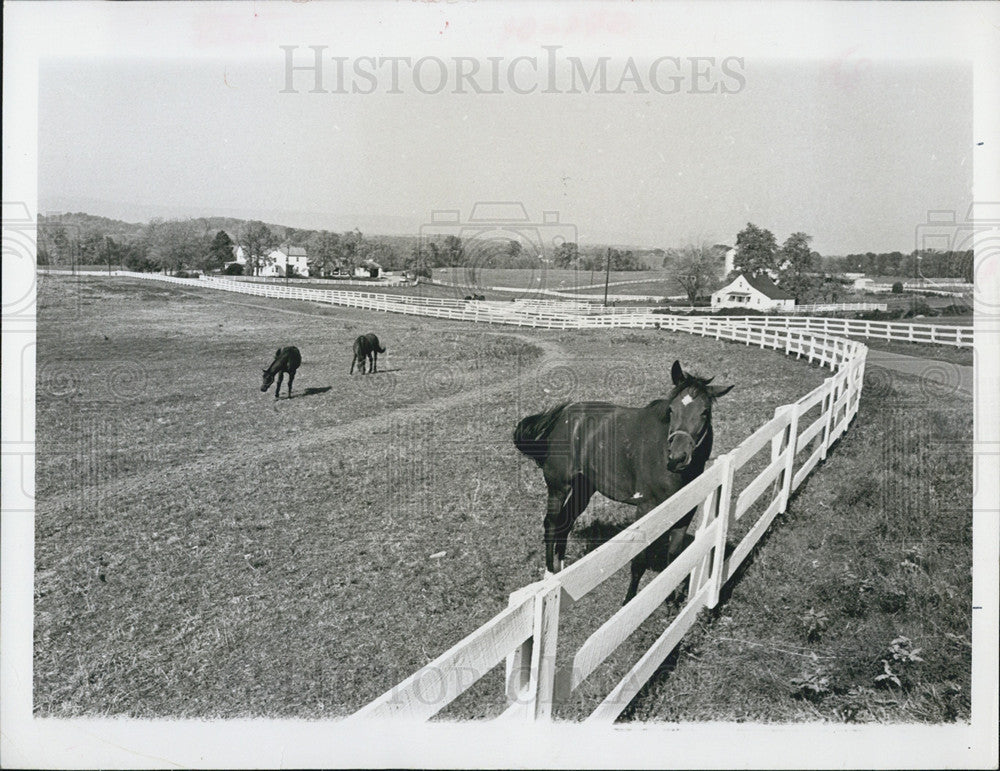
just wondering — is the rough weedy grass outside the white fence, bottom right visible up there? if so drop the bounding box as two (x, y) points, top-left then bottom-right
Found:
(627, 373), (972, 723)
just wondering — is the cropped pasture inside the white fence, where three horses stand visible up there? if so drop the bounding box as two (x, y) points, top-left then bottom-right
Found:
(34, 276), (968, 719)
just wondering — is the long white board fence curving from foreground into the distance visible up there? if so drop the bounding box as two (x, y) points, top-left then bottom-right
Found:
(41, 274), (972, 722)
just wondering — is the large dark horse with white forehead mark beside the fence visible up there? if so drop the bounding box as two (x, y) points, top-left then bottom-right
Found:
(514, 361), (732, 602)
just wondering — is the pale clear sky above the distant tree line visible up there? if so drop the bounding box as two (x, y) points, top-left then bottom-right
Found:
(38, 56), (974, 254)
